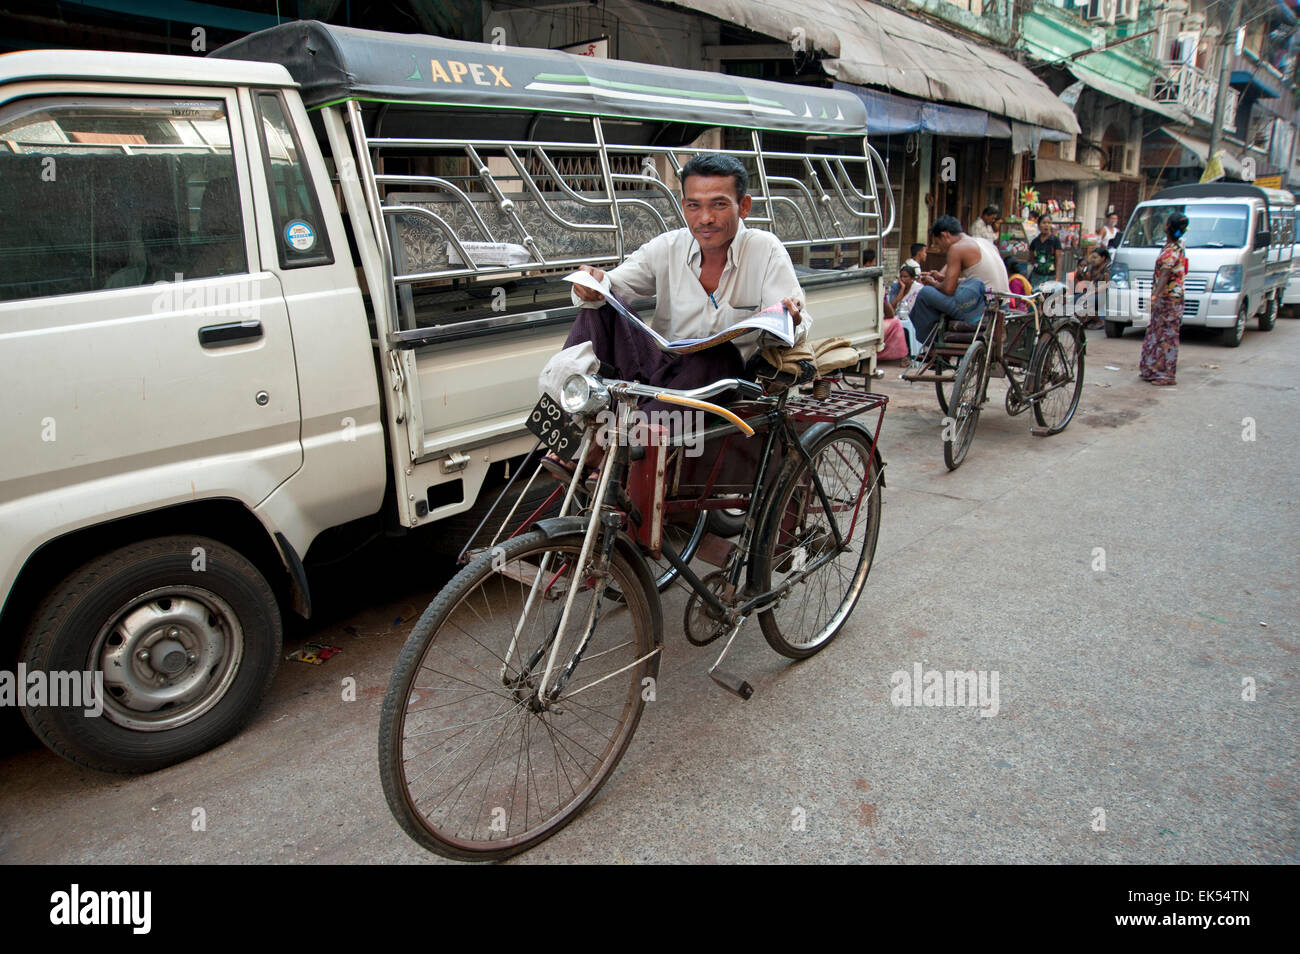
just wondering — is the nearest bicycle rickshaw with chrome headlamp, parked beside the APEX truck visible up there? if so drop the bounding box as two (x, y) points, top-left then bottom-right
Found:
(380, 352), (888, 860)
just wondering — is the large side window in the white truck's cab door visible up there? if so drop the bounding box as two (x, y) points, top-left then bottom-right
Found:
(0, 97), (248, 300)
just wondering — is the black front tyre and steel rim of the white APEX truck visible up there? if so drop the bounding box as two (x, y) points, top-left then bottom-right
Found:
(20, 537), (281, 772)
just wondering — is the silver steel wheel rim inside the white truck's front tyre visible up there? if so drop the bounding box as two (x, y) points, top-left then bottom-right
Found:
(90, 586), (243, 732)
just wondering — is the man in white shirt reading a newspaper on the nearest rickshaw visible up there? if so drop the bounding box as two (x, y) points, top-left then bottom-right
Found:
(538, 155), (811, 421)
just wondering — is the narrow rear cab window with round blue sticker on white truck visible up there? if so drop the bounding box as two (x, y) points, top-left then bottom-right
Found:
(257, 92), (334, 268)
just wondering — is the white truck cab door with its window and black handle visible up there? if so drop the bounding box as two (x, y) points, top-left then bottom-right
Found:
(0, 84), (303, 548)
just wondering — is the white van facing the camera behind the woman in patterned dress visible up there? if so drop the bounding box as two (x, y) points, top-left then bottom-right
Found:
(1106, 182), (1295, 347)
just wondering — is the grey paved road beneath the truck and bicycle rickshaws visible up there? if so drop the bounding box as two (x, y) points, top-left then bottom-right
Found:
(0, 320), (1300, 863)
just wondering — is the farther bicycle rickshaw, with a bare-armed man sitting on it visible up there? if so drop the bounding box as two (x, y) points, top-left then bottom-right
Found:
(901, 291), (1087, 471)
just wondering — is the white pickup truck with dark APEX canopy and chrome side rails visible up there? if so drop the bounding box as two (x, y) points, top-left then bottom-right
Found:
(0, 22), (893, 772)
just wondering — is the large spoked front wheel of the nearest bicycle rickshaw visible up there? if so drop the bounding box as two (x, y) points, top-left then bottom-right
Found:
(380, 532), (658, 860)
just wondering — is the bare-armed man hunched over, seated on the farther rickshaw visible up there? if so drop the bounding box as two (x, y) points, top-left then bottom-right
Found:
(911, 216), (1009, 342)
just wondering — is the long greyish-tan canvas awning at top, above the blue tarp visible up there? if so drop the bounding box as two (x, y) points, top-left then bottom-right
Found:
(667, 0), (1079, 134)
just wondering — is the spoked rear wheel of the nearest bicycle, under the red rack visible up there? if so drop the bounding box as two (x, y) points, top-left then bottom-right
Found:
(754, 426), (880, 659)
